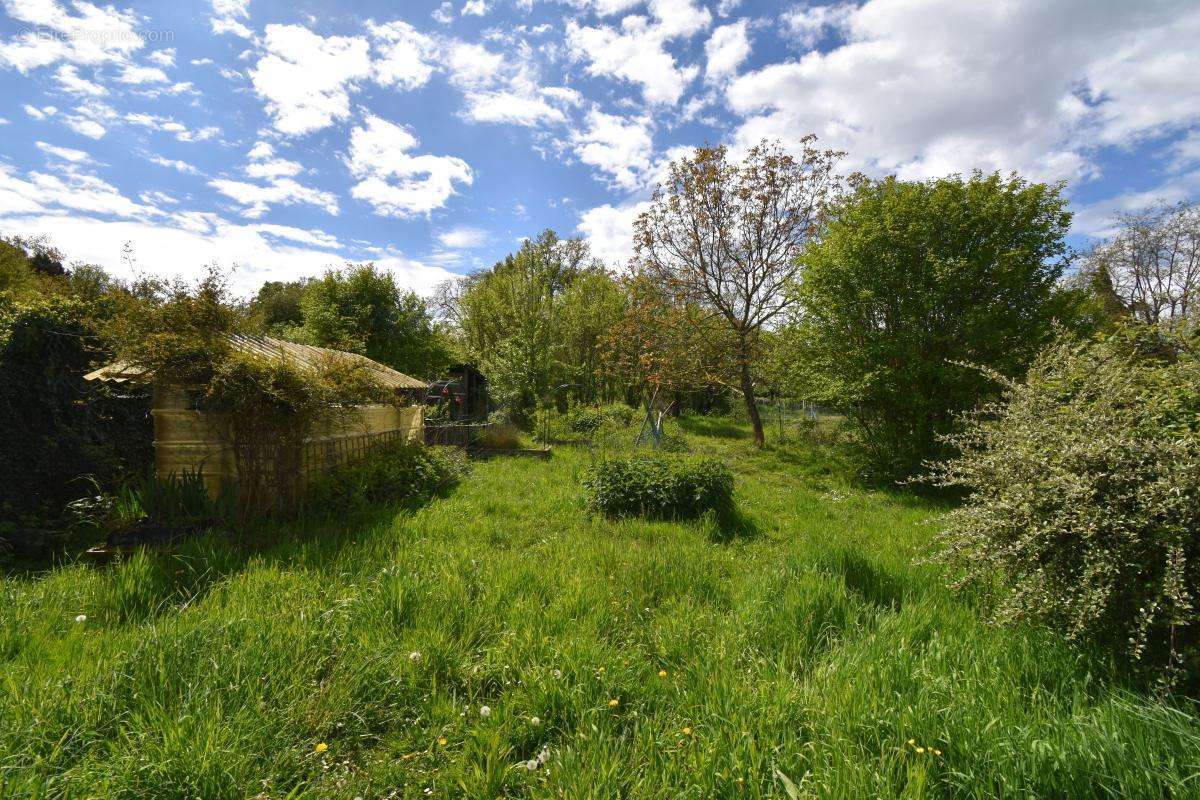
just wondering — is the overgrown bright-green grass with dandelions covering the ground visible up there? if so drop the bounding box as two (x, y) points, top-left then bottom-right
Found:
(0, 419), (1200, 799)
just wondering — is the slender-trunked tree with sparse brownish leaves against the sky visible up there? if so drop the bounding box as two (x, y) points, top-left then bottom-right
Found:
(634, 136), (845, 444)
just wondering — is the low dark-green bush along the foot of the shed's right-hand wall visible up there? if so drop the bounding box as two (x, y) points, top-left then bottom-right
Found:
(305, 444), (468, 513)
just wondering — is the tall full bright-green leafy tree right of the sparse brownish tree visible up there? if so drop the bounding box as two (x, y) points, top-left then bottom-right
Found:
(784, 173), (1080, 479)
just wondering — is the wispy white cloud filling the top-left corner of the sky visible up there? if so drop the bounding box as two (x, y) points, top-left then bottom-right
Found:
(0, 0), (145, 74)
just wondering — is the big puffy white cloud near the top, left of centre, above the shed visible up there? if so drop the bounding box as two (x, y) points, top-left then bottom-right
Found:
(250, 25), (371, 136)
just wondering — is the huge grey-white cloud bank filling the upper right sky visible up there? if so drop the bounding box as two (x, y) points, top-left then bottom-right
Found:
(726, 0), (1200, 180)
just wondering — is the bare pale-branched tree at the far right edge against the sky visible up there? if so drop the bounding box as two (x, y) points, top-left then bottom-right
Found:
(1082, 201), (1200, 325)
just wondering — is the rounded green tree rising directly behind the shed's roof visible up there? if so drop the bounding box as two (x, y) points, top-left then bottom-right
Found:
(298, 264), (451, 378)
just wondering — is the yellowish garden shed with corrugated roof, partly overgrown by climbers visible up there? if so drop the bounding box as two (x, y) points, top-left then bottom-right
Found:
(84, 335), (426, 495)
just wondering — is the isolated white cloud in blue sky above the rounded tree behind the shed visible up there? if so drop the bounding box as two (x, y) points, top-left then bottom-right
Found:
(346, 114), (474, 218)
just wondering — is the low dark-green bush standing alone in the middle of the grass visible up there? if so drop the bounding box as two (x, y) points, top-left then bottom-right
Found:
(583, 456), (733, 518)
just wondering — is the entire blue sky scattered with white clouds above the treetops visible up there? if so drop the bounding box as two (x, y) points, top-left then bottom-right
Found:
(0, 0), (1200, 290)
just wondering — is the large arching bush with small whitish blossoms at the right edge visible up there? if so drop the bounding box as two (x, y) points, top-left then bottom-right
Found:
(931, 329), (1200, 675)
